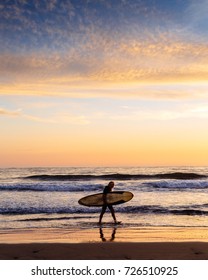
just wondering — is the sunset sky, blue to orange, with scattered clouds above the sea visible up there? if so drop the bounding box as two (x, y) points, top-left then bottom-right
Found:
(0, 0), (208, 167)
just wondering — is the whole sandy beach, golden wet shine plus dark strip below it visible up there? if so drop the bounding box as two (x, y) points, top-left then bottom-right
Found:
(0, 226), (208, 260)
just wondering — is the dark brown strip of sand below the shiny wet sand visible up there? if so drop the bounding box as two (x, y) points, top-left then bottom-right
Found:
(0, 242), (208, 260)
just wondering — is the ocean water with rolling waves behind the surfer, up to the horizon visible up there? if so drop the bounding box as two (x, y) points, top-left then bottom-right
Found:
(0, 167), (208, 230)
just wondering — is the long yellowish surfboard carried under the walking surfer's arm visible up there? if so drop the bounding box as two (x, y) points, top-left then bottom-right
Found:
(78, 191), (134, 207)
